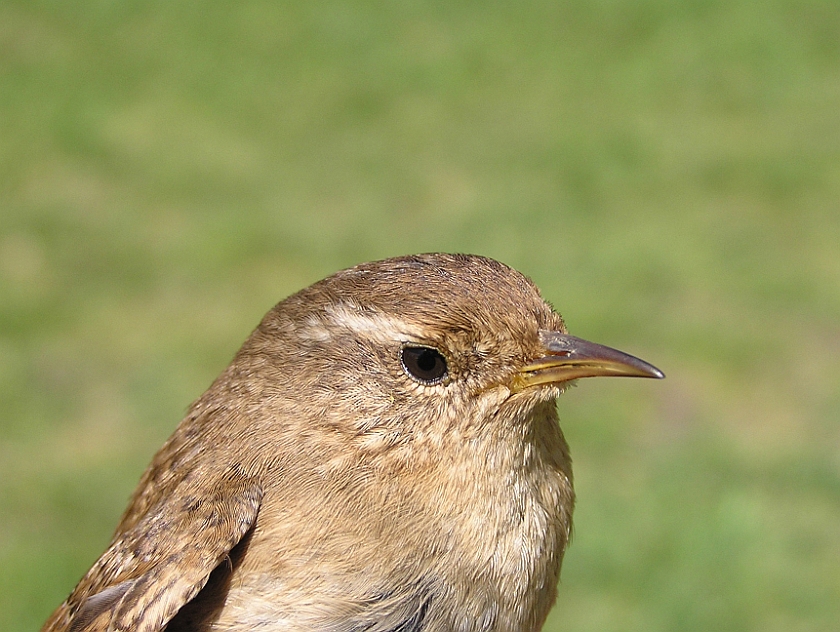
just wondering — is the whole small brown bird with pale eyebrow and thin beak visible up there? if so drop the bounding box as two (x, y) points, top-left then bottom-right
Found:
(43, 254), (663, 632)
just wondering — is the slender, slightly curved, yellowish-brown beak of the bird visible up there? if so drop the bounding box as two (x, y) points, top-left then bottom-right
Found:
(513, 331), (665, 390)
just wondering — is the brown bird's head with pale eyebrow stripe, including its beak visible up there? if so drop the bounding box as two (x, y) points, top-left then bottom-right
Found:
(225, 254), (662, 460)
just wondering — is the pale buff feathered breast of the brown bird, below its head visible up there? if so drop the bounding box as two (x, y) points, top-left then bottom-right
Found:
(208, 407), (572, 632)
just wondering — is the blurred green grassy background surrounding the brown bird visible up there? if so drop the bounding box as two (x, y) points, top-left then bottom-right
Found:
(0, 0), (840, 632)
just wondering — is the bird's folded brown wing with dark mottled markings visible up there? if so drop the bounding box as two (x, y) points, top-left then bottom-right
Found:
(41, 471), (262, 632)
